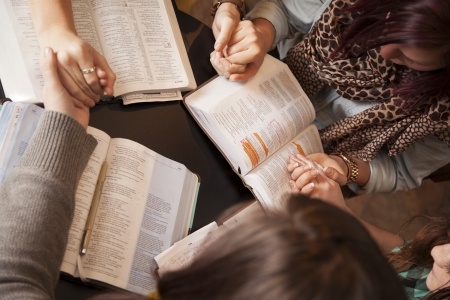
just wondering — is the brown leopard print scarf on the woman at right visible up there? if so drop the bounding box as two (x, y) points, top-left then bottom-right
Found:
(284, 0), (450, 161)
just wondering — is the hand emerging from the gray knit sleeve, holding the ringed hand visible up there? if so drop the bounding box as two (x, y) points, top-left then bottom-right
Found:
(41, 48), (89, 128)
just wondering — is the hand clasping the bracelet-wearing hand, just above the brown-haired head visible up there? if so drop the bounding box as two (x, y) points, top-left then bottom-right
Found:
(287, 154), (350, 211)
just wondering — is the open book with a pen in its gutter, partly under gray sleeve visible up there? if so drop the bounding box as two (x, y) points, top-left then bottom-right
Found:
(0, 102), (200, 294)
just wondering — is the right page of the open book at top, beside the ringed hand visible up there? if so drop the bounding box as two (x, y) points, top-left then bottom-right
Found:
(90, 0), (195, 95)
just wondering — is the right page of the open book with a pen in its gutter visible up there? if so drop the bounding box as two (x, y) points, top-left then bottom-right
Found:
(80, 138), (197, 294)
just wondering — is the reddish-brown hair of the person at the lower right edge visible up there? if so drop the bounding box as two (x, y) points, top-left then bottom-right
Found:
(388, 216), (450, 300)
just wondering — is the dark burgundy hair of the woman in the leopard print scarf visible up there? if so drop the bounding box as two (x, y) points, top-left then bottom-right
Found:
(331, 0), (450, 109)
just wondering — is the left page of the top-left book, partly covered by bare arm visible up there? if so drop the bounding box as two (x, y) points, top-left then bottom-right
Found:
(0, 0), (102, 102)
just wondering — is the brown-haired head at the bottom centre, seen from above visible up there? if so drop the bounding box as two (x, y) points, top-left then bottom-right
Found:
(158, 196), (406, 300)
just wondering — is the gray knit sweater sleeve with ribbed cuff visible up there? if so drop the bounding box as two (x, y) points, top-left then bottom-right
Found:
(0, 111), (97, 299)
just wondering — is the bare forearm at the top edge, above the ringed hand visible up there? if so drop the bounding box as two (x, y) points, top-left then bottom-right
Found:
(29, 0), (76, 39)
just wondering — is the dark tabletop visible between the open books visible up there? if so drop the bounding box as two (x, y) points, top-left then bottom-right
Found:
(55, 5), (253, 300)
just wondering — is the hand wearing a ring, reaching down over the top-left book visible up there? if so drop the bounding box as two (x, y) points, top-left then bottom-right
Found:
(40, 29), (116, 107)
